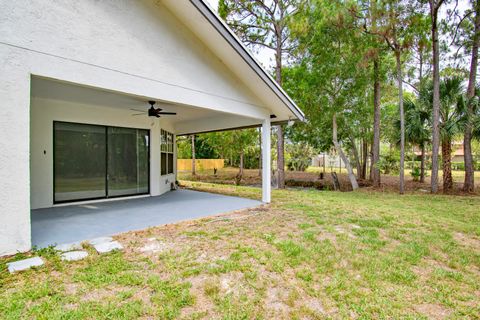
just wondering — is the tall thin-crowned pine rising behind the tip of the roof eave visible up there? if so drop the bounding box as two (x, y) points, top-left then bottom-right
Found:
(219, 0), (302, 188)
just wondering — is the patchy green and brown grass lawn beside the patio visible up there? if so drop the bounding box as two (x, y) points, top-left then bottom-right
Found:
(0, 182), (480, 319)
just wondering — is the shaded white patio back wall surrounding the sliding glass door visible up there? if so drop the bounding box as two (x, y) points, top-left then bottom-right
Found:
(30, 98), (175, 209)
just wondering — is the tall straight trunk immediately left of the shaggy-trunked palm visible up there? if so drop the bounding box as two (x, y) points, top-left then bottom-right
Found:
(430, 0), (440, 193)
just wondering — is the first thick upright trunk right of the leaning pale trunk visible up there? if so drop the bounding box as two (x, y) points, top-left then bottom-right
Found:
(370, 57), (381, 187)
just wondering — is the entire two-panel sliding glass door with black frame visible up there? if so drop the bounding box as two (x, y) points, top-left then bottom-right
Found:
(54, 122), (149, 203)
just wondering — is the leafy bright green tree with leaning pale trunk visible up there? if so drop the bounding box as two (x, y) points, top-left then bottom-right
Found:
(285, 0), (371, 190)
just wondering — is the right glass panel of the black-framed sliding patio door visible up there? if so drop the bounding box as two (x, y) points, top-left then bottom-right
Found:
(107, 127), (149, 197)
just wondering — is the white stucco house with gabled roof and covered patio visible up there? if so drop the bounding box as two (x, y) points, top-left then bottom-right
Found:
(0, 0), (304, 255)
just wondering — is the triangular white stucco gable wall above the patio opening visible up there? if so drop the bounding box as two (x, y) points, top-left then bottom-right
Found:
(0, 0), (268, 118)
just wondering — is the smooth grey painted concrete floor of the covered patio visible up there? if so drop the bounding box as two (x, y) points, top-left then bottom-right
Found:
(31, 190), (261, 248)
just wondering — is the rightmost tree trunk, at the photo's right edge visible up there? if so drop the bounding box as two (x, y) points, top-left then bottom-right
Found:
(463, 0), (480, 192)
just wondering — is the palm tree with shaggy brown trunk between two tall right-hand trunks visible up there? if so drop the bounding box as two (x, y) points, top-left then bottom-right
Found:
(419, 76), (466, 192)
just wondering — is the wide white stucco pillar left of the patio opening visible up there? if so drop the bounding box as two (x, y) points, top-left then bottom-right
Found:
(0, 55), (31, 256)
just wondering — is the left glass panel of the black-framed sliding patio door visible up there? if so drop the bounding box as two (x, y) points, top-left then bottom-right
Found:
(54, 122), (106, 202)
